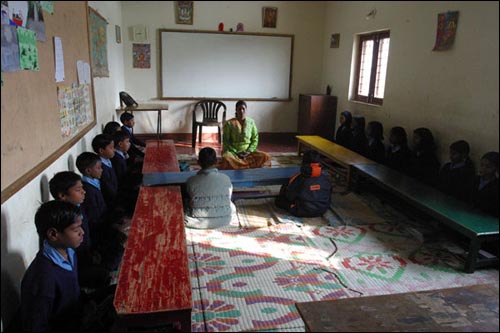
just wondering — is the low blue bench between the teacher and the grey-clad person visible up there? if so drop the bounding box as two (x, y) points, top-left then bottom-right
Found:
(143, 166), (300, 188)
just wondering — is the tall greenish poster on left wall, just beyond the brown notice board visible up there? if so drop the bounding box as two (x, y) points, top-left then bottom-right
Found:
(89, 7), (109, 77)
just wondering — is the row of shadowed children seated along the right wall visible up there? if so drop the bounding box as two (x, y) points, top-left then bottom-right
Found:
(335, 111), (498, 216)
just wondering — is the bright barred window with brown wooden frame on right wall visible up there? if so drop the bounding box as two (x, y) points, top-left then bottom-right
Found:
(354, 31), (390, 105)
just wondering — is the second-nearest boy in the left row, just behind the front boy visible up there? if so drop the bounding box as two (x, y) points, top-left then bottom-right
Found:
(49, 171), (110, 288)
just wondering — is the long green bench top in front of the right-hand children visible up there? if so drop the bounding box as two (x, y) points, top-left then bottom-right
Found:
(355, 164), (498, 237)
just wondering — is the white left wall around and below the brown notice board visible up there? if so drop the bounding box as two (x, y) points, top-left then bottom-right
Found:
(1, 1), (124, 328)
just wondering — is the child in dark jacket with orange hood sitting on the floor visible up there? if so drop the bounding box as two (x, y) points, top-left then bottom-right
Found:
(276, 150), (331, 217)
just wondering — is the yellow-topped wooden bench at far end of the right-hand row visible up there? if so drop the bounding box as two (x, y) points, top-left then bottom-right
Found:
(296, 135), (376, 185)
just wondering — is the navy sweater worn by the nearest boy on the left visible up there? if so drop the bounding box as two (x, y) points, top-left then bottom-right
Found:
(21, 250), (80, 332)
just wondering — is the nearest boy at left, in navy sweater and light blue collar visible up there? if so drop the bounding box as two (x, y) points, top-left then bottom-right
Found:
(20, 200), (116, 332)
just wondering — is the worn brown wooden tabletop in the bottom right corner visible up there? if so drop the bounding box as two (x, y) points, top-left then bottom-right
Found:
(295, 284), (498, 332)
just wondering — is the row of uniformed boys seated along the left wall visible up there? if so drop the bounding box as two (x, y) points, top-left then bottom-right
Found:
(19, 116), (145, 331)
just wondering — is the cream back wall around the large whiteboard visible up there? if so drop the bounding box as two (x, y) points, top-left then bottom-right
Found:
(119, 1), (326, 133)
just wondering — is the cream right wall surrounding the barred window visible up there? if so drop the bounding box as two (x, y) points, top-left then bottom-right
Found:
(322, 1), (499, 165)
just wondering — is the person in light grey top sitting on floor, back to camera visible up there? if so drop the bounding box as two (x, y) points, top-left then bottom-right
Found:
(184, 147), (236, 229)
